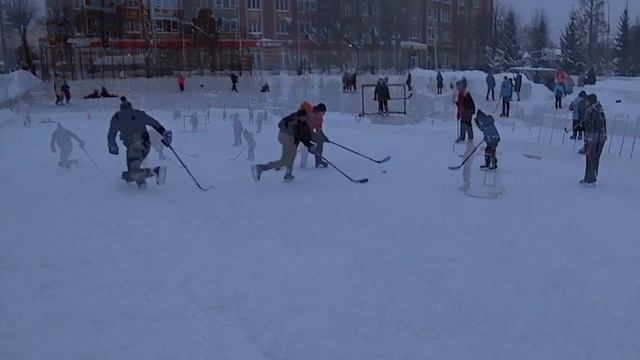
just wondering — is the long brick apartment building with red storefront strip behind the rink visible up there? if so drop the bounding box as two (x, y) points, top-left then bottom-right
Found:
(46, 0), (493, 77)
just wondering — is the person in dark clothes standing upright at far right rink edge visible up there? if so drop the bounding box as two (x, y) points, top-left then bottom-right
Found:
(580, 94), (607, 185)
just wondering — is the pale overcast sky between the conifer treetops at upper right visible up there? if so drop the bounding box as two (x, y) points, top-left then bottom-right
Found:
(510, 0), (640, 44)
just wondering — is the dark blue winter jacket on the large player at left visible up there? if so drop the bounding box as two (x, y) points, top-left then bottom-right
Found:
(107, 102), (166, 148)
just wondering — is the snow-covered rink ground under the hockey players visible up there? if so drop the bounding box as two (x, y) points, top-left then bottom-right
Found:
(0, 74), (640, 360)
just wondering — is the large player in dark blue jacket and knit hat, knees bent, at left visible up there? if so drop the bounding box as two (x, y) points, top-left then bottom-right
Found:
(107, 96), (173, 189)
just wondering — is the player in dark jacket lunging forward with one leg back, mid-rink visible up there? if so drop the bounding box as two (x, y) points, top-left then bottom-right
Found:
(251, 102), (315, 182)
